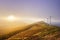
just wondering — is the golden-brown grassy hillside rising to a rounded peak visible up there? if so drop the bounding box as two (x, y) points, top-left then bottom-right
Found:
(1, 21), (60, 40)
